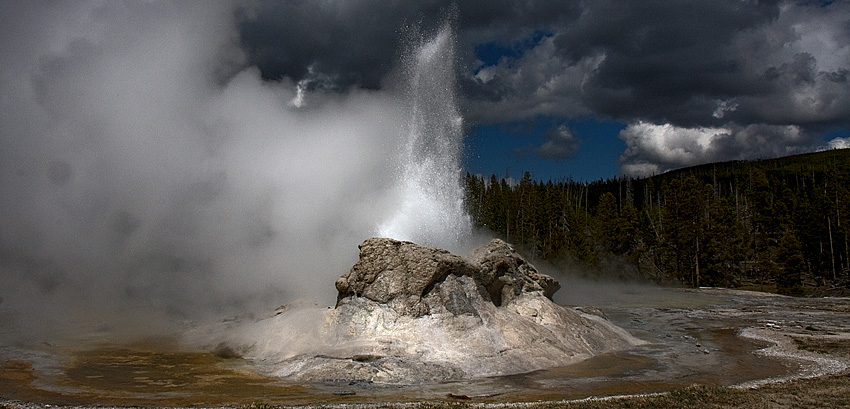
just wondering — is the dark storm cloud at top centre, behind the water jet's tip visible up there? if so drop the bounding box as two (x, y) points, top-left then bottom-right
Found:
(232, 0), (578, 90)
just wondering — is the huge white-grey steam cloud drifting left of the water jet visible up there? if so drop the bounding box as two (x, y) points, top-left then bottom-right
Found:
(0, 2), (434, 338)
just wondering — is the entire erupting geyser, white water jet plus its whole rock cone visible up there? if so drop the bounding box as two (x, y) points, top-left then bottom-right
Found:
(184, 24), (642, 384)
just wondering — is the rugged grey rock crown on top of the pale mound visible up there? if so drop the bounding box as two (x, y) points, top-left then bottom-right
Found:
(336, 238), (561, 317)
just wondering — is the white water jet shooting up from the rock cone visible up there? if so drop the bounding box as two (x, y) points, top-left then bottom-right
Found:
(378, 23), (472, 250)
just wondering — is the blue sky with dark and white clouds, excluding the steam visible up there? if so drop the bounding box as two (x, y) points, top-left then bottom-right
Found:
(232, 0), (850, 180)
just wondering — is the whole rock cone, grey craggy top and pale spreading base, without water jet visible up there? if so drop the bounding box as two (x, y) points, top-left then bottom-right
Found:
(192, 238), (643, 384)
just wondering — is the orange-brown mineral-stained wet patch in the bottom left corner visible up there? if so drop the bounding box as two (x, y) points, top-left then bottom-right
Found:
(0, 347), (322, 406)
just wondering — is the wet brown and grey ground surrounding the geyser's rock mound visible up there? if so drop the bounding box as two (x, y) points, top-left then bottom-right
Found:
(0, 287), (850, 406)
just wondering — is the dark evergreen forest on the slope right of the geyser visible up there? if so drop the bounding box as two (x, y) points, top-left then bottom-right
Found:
(465, 149), (850, 295)
